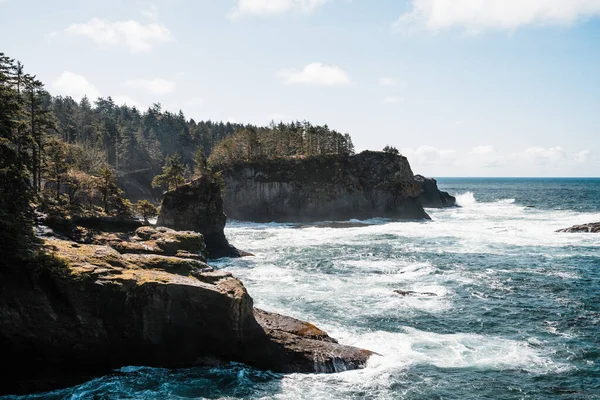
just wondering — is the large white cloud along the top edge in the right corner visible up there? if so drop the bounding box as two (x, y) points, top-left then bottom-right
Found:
(395, 0), (600, 33)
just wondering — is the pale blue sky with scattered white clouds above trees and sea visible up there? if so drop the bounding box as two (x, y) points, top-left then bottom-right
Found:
(0, 0), (600, 177)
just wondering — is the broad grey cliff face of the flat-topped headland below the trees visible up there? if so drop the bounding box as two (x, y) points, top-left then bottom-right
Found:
(222, 152), (429, 222)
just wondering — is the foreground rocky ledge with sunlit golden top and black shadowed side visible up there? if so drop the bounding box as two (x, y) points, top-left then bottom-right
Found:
(0, 236), (372, 394)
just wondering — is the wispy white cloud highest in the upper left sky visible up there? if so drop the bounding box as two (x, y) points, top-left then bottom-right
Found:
(65, 18), (173, 53)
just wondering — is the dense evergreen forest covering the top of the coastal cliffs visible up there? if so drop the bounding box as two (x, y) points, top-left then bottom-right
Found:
(0, 53), (354, 240)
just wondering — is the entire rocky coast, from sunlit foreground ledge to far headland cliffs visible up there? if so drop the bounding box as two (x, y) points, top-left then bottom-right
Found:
(0, 152), (455, 394)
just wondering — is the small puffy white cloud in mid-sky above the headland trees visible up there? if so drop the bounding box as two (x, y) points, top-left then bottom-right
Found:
(277, 62), (350, 86)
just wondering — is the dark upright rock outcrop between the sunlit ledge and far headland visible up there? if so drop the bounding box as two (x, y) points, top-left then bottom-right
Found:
(157, 176), (250, 258)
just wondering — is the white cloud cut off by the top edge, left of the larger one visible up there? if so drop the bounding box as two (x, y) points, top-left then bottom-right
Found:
(229, 0), (327, 19)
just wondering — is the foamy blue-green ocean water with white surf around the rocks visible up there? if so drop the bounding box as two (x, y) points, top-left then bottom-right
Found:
(8, 178), (600, 399)
